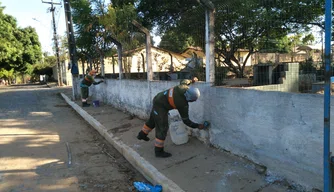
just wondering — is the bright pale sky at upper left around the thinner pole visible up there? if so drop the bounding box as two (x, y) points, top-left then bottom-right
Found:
(0, 0), (66, 54)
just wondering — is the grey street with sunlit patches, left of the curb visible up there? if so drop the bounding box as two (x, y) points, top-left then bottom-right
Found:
(0, 85), (145, 192)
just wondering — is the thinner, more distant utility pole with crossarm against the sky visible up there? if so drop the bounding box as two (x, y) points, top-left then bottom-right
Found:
(42, 0), (63, 86)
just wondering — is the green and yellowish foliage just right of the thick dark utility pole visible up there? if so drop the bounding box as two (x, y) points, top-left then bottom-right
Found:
(71, 0), (145, 75)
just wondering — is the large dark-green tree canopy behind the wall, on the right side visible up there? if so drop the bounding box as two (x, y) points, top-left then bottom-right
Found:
(137, 0), (324, 77)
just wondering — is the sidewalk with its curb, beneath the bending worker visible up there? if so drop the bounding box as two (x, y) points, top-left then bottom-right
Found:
(62, 92), (297, 192)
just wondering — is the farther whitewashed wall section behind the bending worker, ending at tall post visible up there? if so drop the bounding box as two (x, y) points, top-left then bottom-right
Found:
(85, 79), (207, 121)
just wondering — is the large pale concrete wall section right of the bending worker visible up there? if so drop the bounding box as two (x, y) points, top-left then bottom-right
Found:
(207, 88), (328, 189)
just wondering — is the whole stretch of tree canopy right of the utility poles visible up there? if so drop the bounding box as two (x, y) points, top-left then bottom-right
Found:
(71, 0), (324, 77)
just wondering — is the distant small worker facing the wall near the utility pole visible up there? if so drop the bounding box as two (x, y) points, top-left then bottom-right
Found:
(80, 69), (103, 107)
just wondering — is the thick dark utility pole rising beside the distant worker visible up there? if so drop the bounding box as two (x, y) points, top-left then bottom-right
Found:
(64, 0), (78, 100)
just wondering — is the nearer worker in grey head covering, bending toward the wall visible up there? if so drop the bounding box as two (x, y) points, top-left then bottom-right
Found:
(137, 77), (210, 158)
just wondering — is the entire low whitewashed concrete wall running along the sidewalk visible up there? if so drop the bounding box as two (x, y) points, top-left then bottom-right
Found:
(77, 80), (334, 190)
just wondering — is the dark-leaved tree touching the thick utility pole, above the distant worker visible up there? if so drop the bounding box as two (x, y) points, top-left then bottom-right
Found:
(71, 0), (121, 74)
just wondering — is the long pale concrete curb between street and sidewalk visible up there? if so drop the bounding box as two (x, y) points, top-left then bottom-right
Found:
(61, 93), (184, 192)
